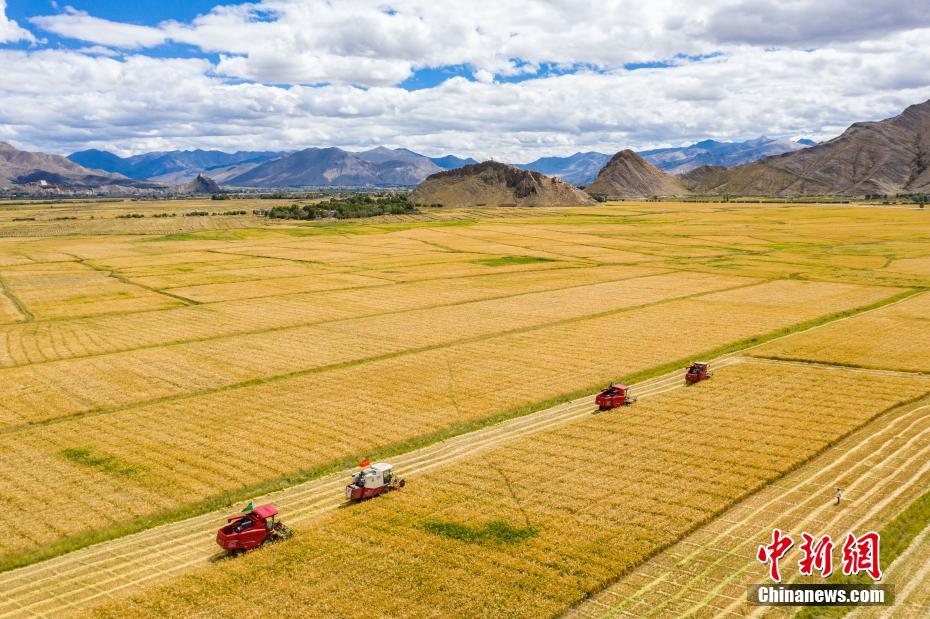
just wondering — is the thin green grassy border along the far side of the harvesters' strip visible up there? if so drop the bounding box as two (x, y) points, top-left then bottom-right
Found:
(0, 289), (912, 574)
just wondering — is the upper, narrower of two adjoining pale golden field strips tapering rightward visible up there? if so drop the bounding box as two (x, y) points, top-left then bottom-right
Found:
(0, 267), (661, 367)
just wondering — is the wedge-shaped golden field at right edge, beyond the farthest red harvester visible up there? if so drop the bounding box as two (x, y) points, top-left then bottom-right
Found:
(753, 293), (930, 372)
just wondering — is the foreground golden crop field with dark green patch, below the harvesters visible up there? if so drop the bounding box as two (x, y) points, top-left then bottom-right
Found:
(87, 362), (930, 617)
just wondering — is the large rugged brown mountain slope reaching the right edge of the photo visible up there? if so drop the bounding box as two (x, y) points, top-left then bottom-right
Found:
(681, 101), (930, 196)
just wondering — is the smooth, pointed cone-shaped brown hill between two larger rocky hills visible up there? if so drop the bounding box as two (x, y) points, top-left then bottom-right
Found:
(587, 150), (688, 199)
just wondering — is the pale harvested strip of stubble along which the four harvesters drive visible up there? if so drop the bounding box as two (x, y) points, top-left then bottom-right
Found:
(0, 355), (741, 617)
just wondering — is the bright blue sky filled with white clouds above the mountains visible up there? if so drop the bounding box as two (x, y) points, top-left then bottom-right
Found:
(0, 0), (930, 161)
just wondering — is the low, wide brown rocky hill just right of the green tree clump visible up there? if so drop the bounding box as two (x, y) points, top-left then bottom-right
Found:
(410, 161), (594, 206)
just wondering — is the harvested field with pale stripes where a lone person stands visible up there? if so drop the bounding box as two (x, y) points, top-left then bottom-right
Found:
(567, 392), (930, 617)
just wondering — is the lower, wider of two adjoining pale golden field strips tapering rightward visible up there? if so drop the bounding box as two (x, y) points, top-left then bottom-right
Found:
(0, 274), (753, 431)
